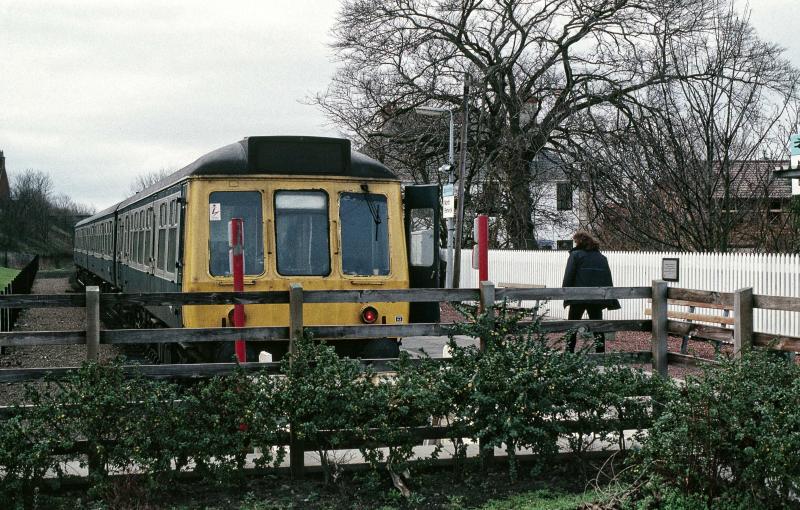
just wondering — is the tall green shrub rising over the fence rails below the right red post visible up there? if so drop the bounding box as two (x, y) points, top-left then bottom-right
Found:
(450, 305), (653, 480)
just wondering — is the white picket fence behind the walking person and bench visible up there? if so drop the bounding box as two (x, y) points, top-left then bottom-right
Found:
(460, 250), (800, 337)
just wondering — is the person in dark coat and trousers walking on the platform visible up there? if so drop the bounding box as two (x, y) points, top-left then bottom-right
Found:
(562, 231), (620, 352)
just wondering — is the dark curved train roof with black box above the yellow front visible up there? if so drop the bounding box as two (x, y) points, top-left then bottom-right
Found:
(76, 136), (399, 226)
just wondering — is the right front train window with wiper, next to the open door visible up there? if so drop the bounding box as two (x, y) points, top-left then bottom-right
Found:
(339, 193), (389, 276)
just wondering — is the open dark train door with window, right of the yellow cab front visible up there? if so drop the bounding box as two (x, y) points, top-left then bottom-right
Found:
(405, 184), (441, 322)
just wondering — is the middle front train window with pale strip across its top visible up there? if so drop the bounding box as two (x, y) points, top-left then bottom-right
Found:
(275, 191), (331, 276)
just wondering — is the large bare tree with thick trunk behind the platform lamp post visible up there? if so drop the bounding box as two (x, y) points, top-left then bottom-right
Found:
(315, 0), (714, 248)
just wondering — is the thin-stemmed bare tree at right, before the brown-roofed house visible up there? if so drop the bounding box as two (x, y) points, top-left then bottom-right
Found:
(572, 8), (800, 251)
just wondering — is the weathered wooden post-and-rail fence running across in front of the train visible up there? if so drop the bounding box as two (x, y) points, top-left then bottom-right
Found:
(0, 280), (800, 476)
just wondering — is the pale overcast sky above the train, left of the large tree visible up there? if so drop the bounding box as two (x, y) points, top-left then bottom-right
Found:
(0, 0), (800, 209)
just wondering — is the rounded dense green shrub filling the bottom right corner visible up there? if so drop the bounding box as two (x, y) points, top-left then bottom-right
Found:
(636, 351), (800, 507)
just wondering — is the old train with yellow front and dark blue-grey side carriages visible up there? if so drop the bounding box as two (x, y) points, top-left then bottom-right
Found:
(73, 136), (441, 362)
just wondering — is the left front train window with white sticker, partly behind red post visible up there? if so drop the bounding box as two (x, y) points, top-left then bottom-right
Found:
(208, 191), (264, 276)
